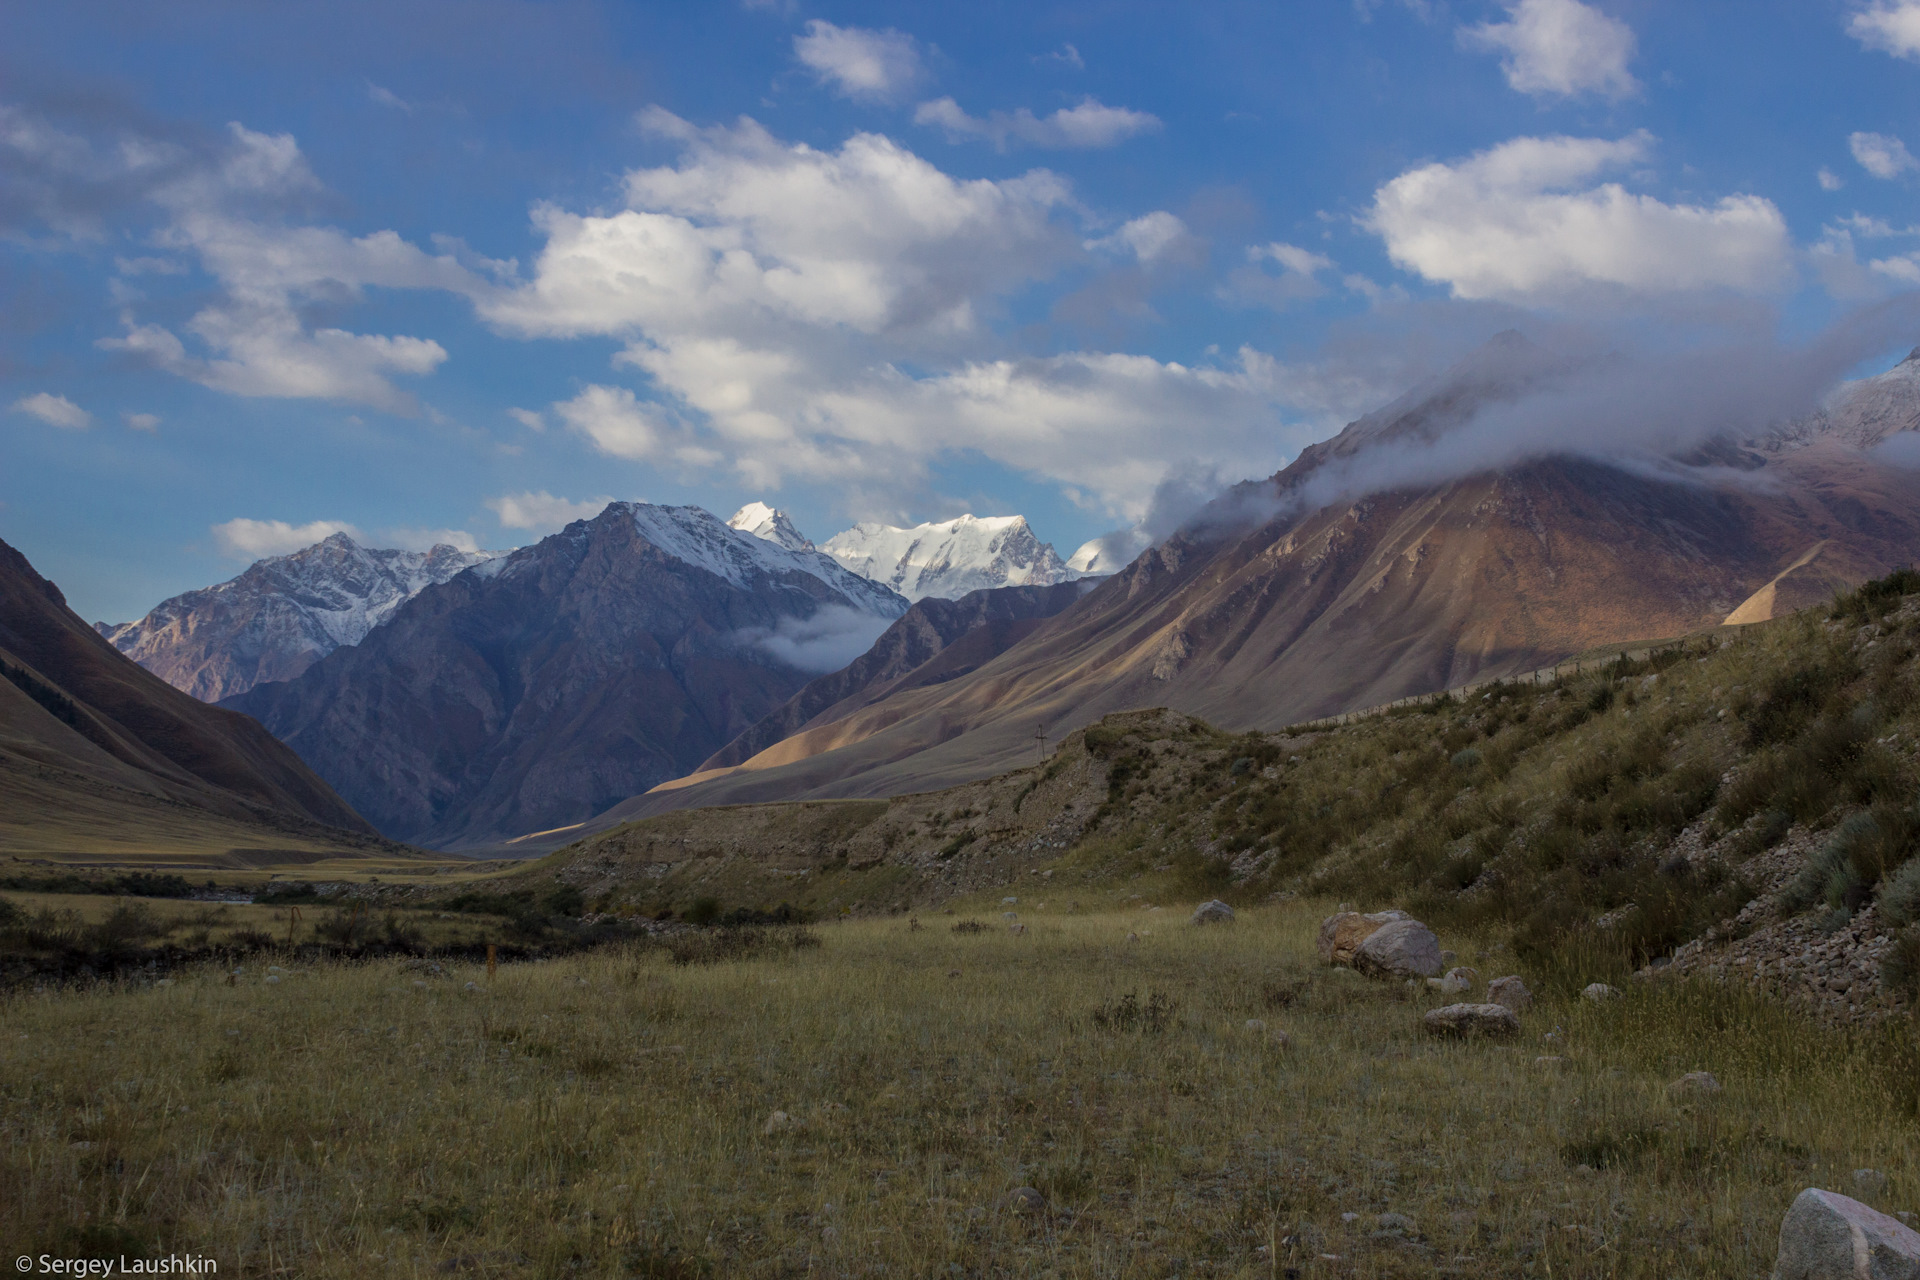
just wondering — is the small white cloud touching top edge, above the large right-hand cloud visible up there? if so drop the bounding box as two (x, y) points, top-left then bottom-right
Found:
(1459, 0), (1640, 98)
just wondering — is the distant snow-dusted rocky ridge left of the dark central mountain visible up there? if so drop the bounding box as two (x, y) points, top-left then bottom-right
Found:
(94, 533), (507, 702)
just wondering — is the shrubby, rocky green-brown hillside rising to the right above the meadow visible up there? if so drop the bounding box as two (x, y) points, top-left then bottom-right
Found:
(501, 572), (1920, 1015)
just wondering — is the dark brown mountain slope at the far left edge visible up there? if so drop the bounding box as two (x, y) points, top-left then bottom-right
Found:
(0, 543), (385, 848)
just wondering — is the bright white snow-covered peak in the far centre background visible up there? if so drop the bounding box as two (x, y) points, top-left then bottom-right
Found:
(822, 516), (1079, 601)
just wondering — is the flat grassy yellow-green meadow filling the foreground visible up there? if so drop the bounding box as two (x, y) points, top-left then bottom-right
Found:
(0, 900), (1920, 1280)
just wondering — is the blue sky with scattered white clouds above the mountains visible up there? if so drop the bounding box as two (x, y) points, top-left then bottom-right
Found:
(0, 0), (1920, 620)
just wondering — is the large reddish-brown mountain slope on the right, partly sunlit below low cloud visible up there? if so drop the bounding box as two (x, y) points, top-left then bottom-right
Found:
(595, 345), (1920, 825)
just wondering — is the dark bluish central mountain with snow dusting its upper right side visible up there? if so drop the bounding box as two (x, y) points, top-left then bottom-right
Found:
(223, 503), (908, 848)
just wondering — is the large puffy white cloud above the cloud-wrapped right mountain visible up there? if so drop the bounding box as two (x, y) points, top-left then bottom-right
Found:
(1363, 132), (1791, 303)
